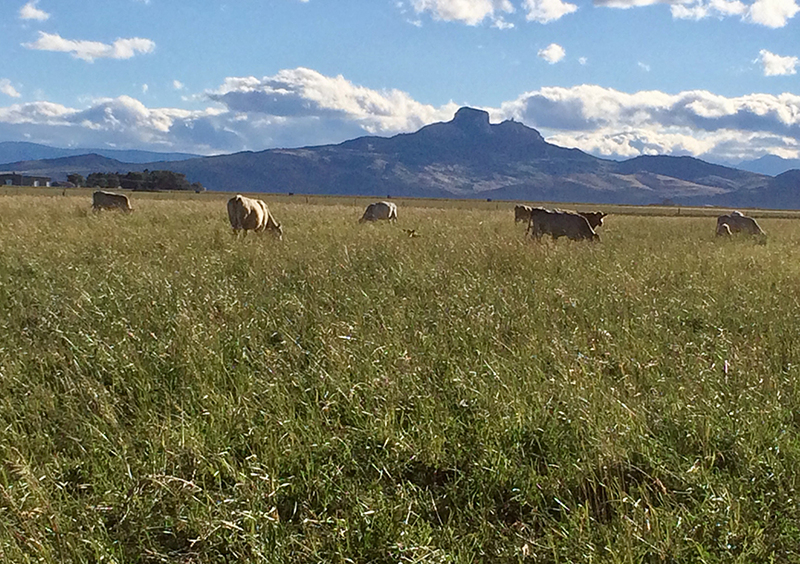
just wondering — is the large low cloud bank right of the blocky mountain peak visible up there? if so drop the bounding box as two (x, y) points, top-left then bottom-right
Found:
(495, 85), (800, 159)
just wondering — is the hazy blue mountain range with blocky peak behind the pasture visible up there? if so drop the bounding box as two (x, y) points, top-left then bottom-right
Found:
(0, 108), (800, 208)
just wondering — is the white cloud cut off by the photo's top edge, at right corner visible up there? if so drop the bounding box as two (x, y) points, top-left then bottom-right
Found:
(594, 0), (800, 28)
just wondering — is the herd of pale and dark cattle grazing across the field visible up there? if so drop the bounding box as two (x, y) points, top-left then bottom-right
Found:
(92, 190), (765, 241)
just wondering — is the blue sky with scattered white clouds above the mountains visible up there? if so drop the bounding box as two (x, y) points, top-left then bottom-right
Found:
(0, 0), (800, 162)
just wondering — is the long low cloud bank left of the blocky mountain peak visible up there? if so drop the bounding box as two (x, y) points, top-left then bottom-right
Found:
(0, 68), (458, 154)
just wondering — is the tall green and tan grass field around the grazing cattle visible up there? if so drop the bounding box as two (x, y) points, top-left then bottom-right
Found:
(0, 189), (800, 563)
